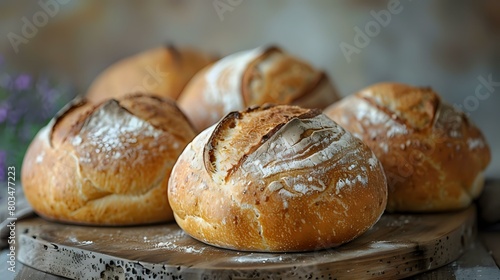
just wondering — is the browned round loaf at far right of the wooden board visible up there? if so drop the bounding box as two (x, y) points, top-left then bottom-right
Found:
(324, 83), (491, 212)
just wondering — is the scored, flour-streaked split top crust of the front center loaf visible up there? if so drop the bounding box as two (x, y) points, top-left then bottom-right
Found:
(204, 106), (378, 198)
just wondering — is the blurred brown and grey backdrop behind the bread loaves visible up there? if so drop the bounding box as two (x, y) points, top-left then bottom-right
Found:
(0, 0), (500, 181)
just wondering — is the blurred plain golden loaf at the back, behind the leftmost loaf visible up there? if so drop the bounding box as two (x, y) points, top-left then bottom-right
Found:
(87, 46), (215, 103)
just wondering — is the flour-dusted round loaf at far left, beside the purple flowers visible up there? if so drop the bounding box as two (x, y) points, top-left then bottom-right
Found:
(21, 95), (195, 225)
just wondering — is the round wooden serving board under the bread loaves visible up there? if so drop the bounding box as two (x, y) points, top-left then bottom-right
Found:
(18, 206), (476, 279)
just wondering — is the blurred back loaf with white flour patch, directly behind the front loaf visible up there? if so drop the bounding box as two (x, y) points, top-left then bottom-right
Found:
(178, 47), (339, 131)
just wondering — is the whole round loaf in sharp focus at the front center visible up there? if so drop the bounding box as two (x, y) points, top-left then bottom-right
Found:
(168, 105), (387, 252)
